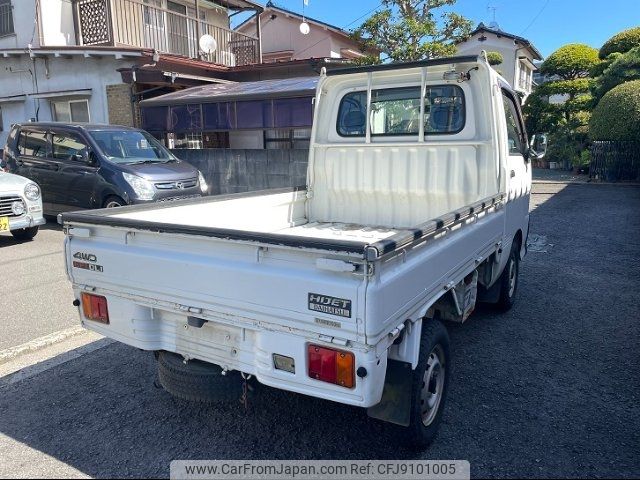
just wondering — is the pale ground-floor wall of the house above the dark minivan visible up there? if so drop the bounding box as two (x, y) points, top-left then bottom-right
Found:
(0, 55), (131, 145)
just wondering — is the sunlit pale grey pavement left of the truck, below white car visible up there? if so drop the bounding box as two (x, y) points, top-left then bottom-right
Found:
(0, 221), (79, 350)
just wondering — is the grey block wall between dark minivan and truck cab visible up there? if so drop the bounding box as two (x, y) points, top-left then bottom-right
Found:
(172, 148), (309, 195)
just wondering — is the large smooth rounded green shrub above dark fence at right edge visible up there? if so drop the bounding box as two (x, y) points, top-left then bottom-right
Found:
(589, 80), (640, 141)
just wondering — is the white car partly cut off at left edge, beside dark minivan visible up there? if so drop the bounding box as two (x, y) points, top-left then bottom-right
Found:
(0, 170), (46, 240)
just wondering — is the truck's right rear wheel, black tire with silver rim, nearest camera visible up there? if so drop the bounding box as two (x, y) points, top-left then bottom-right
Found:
(407, 319), (451, 449)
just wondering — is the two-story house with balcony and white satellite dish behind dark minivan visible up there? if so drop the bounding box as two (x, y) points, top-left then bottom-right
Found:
(0, 0), (262, 148)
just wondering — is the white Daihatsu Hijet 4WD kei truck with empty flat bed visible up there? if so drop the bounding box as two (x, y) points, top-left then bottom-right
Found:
(59, 54), (545, 447)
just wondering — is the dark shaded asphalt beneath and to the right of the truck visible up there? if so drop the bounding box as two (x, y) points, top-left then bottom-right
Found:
(0, 184), (640, 477)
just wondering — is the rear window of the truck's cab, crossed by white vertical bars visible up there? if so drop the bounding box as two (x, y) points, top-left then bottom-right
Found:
(336, 85), (465, 137)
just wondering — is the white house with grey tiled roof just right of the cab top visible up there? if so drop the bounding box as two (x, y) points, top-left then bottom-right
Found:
(457, 22), (543, 103)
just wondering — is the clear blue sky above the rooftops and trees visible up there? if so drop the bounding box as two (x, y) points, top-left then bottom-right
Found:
(234, 0), (640, 57)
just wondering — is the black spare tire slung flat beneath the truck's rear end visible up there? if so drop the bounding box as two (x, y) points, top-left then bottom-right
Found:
(157, 351), (242, 404)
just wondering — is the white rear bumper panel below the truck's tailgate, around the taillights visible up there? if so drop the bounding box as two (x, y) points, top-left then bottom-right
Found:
(74, 288), (387, 407)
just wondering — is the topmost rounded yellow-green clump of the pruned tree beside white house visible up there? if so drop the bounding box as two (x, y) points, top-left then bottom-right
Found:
(540, 43), (600, 80)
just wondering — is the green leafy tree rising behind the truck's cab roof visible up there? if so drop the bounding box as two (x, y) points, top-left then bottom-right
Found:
(352, 0), (472, 63)
